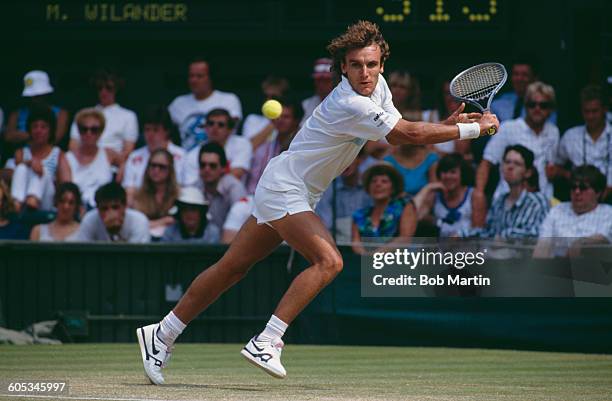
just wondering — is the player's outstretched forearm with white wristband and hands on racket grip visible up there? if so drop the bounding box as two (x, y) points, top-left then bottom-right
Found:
(387, 104), (499, 145)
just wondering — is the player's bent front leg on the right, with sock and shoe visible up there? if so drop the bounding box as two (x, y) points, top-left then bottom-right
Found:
(241, 212), (342, 378)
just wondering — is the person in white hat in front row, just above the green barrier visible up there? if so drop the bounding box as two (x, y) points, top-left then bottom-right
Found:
(161, 187), (221, 244)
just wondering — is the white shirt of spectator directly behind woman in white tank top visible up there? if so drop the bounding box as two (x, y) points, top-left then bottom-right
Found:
(70, 103), (138, 153)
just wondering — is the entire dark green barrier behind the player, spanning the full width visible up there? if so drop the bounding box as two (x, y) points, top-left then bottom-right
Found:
(0, 243), (612, 353)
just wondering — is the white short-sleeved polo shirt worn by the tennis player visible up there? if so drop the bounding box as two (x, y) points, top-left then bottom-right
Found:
(258, 75), (401, 196)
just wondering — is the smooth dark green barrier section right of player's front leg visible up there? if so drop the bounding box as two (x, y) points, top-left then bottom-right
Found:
(300, 248), (612, 353)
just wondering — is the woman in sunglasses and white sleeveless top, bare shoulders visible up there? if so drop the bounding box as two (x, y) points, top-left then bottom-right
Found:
(66, 108), (119, 209)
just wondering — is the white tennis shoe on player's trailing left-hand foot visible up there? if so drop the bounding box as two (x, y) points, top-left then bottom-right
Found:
(136, 323), (174, 384)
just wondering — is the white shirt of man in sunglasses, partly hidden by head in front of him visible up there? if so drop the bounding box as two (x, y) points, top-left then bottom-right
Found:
(182, 134), (253, 186)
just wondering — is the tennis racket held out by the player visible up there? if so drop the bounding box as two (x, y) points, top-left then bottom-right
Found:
(450, 63), (508, 135)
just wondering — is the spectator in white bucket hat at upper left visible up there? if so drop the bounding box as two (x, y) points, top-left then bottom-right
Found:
(4, 70), (68, 151)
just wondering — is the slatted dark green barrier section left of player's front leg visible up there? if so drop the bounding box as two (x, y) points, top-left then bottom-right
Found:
(0, 242), (290, 342)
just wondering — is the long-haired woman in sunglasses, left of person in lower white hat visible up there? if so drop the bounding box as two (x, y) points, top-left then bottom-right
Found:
(133, 149), (179, 240)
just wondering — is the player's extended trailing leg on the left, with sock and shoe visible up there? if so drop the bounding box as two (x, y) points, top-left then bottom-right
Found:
(136, 217), (282, 384)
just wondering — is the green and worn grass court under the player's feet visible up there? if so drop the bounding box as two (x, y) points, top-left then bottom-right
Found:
(0, 342), (612, 401)
